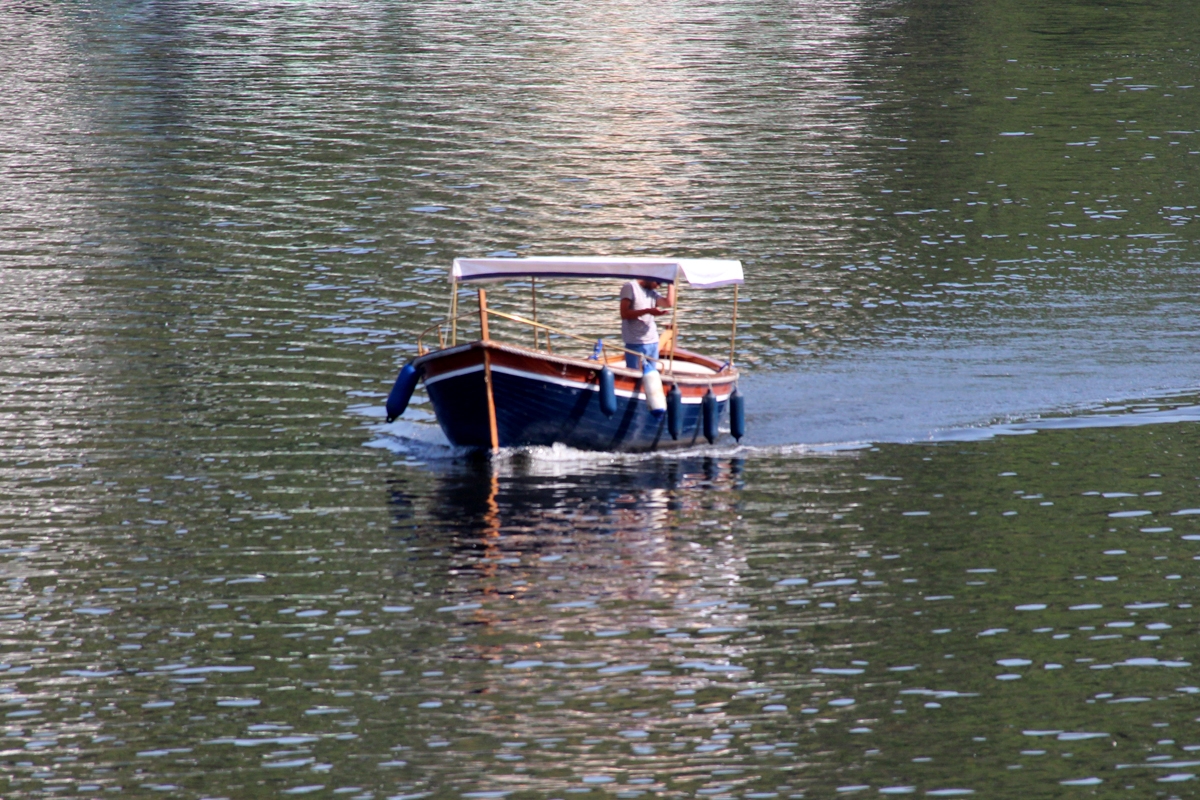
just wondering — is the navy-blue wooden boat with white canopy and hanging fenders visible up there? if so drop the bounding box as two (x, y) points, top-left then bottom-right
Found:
(386, 257), (745, 452)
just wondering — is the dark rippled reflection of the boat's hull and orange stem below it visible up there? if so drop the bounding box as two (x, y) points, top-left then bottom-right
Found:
(392, 449), (742, 614)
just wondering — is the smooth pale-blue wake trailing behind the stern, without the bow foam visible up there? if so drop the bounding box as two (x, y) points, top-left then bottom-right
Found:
(740, 326), (1200, 446)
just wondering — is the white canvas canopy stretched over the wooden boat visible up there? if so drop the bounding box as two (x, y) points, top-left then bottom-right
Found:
(450, 255), (744, 289)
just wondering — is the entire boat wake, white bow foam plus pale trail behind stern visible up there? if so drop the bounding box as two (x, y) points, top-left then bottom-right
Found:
(350, 328), (1200, 473)
